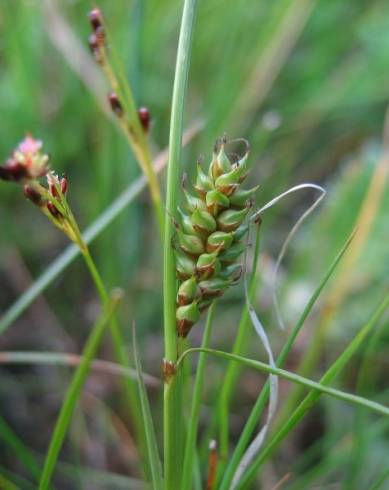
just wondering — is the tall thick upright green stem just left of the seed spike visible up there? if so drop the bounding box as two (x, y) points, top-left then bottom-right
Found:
(163, 0), (197, 490)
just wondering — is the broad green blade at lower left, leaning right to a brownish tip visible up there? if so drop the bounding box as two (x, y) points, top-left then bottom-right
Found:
(38, 301), (117, 490)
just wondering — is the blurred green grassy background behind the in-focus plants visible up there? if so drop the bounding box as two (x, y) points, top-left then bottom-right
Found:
(0, 0), (389, 489)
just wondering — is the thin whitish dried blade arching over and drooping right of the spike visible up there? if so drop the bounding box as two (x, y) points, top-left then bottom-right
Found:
(250, 183), (326, 330)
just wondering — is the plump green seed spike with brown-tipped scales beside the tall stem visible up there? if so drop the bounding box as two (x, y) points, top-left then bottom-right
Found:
(176, 138), (257, 337)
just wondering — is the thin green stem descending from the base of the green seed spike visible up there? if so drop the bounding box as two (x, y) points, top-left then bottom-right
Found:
(181, 302), (215, 490)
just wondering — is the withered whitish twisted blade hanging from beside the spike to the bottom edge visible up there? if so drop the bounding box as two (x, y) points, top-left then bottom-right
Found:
(231, 231), (278, 490)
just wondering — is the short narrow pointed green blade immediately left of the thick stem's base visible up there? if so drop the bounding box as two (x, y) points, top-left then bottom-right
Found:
(132, 325), (163, 490)
